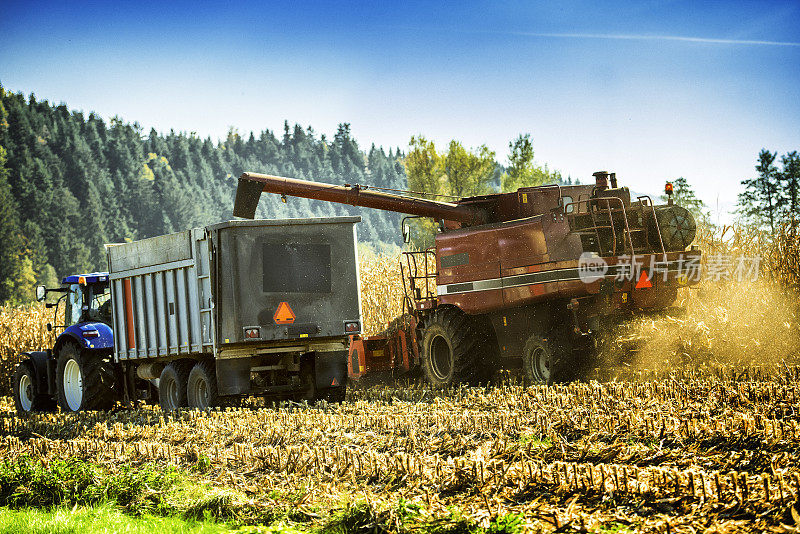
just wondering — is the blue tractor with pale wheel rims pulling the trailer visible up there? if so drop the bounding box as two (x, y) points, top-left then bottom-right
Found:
(13, 273), (123, 414)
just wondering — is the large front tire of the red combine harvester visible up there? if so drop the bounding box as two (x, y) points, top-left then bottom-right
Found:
(422, 308), (494, 388)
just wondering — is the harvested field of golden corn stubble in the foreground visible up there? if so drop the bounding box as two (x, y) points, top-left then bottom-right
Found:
(0, 366), (800, 532)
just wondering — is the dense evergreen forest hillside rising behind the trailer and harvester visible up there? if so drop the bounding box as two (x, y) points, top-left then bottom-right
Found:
(0, 85), (562, 304)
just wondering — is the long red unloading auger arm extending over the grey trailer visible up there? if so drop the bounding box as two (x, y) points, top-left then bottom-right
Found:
(233, 172), (485, 225)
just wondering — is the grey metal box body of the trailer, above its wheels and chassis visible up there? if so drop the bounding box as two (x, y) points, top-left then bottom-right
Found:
(107, 217), (361, 360)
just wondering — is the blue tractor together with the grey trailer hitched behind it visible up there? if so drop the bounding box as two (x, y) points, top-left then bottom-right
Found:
(14, 217), (361, 414)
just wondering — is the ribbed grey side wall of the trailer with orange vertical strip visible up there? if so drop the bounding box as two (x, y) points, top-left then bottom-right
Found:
(107, 228), (214, 361)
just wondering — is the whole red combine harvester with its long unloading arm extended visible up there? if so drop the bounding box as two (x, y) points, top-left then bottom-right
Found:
(234, 172), (700, 387)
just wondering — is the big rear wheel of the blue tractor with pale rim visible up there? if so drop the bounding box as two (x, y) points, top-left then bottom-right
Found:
(56, 343), (119, 412)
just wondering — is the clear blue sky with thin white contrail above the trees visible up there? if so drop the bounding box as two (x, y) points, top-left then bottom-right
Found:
(0, 0), (800, 220)
